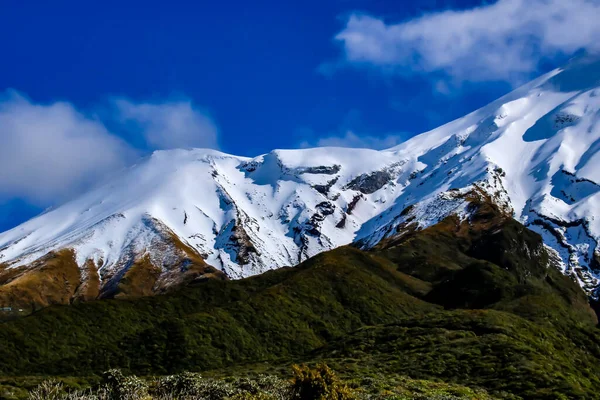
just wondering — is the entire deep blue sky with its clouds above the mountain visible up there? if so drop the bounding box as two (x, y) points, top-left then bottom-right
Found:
(0, 0), (600, 231)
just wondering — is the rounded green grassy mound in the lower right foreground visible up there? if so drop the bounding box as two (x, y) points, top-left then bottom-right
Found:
(310, 310), (600, 399)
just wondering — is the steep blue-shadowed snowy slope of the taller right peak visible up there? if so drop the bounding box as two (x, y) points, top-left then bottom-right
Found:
(358, 55), (600, 292)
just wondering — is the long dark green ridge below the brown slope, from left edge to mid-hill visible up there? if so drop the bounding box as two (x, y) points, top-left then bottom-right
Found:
(0, 248), (439, 374)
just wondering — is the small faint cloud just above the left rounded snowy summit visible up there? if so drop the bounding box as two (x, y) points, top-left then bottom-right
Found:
(115, 99), (218, 149)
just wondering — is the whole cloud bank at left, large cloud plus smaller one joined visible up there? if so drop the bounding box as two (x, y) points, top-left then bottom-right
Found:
(0, 90), (217, 207)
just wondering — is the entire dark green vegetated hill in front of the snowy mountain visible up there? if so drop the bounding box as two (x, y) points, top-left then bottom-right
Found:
(0, 200), (600, 399)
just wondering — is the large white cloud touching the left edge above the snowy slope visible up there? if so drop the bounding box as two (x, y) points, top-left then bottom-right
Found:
(0, 91), (133, 206)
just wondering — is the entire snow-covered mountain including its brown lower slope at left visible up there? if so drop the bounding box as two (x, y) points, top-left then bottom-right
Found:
(0, 54), (600, 311)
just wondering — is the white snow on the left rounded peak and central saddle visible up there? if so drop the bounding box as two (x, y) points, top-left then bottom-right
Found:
(0, 148), (404, 278)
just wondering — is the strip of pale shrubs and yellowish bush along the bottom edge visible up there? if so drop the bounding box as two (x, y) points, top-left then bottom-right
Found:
(19, 364), (493, 400)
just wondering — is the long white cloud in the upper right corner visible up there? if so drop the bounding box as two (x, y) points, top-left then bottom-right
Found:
(335, 0), (600, 81)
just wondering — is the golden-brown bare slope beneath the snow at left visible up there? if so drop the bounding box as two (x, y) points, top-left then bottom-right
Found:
(0, 227), (227, 314)
